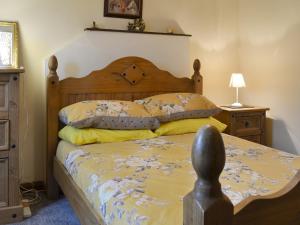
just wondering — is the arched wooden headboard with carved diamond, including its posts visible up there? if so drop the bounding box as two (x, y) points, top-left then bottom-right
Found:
(47, 56), (203, 198)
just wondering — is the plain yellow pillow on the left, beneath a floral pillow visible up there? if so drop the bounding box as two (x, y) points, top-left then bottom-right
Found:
(58, 126), (157, 145)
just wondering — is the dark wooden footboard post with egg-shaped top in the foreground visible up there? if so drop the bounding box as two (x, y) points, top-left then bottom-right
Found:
(183, 126), (233, 225)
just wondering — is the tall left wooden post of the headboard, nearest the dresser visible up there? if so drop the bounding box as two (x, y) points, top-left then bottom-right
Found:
(47, 56), (60, 199)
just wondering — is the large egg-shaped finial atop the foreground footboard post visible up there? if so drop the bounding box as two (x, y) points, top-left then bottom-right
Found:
(192, 126), (225, 185)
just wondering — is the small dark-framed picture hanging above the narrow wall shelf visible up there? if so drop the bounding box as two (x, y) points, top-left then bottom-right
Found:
(104, 0), (143, 19)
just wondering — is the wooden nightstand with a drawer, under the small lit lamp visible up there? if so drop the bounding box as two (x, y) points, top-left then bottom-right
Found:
(215, 107), (269, 145)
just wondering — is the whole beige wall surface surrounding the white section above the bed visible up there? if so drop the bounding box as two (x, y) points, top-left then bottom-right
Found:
(0, 0), (300, 181)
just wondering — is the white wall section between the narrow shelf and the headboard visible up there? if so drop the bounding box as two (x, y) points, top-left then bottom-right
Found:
(49, 32), (192, 79)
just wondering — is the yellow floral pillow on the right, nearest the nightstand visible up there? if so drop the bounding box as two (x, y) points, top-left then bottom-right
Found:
(135, 93), (221, 122)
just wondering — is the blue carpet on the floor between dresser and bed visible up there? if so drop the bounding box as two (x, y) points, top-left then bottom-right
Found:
(11, 199), (80, 225)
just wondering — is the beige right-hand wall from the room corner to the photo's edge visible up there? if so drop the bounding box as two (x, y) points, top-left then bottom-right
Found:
(238, 0), (300, 153)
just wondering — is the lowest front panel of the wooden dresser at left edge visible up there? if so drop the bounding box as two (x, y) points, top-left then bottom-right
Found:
(0, 158), (8, 208)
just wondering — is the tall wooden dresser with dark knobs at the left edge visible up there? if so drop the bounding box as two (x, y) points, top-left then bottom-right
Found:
(0, 69), (24, 224)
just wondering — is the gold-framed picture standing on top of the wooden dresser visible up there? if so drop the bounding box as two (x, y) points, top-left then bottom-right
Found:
(0, 21), (18, 68)
